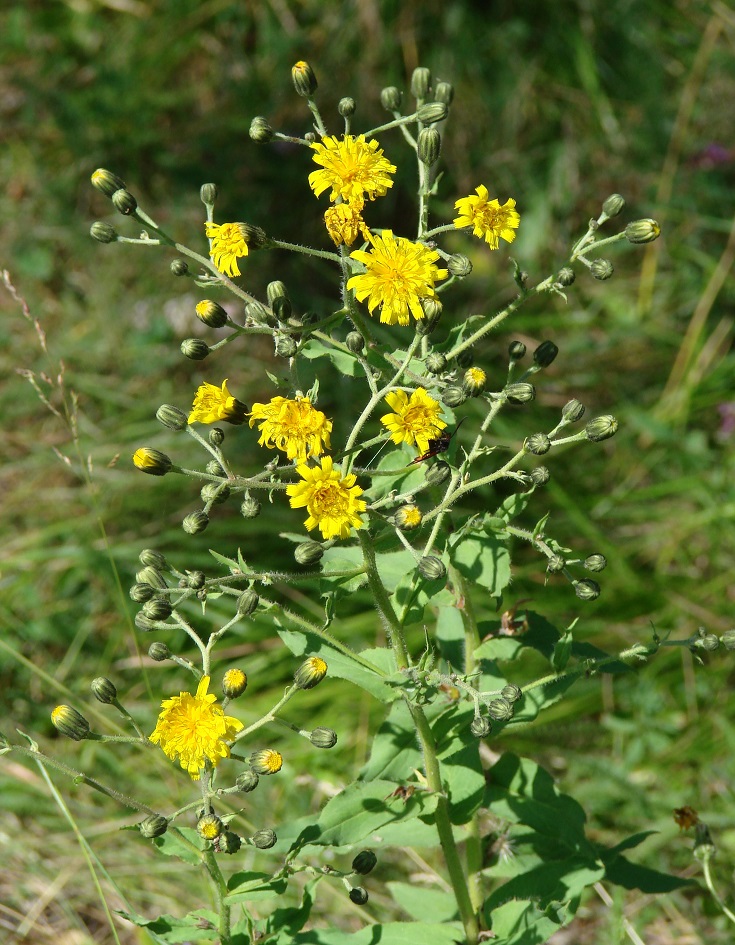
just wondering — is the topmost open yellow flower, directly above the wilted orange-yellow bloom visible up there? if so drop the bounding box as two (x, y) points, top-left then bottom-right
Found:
(309, 135), (396, 210)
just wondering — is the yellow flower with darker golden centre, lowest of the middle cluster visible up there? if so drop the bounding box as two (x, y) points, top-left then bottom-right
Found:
(286, 456), (366, 538)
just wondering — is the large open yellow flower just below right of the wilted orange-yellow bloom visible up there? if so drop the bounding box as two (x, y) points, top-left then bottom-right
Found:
(347, 230), (447, 325)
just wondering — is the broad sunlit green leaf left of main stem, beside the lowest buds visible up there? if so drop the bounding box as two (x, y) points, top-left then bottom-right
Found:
(311, 780), (437, 846)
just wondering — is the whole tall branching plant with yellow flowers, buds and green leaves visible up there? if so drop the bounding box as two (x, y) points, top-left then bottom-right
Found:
(4, 62), (732, 945)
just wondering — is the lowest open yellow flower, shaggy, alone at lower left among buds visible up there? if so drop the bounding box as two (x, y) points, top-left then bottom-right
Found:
(149, 676), (243, 781)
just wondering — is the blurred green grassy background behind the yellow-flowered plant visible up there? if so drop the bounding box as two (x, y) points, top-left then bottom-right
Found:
(0, 0), (735, 945)
